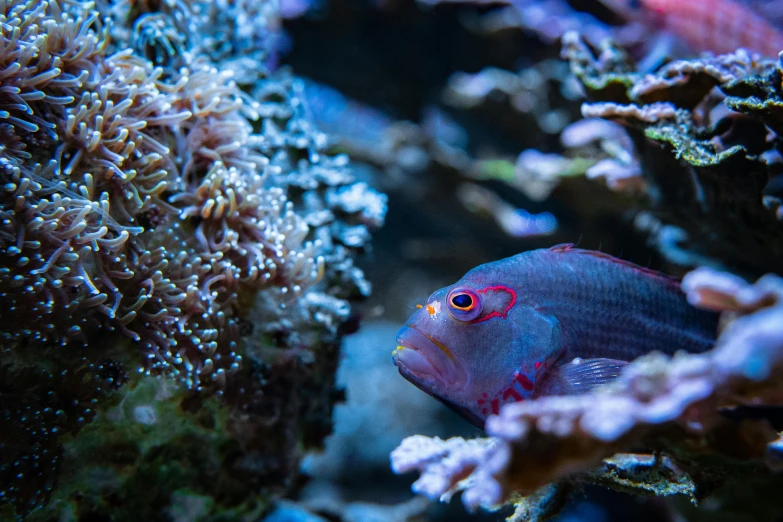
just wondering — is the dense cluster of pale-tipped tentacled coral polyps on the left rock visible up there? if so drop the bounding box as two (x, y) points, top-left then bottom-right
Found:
(3, 2), (380, 374)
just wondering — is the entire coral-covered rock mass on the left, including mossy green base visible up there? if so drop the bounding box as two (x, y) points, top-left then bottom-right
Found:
(0, 0), (386, 520)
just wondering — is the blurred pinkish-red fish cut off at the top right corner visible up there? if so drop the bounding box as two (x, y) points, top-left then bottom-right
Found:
(600, 0), (783, 58)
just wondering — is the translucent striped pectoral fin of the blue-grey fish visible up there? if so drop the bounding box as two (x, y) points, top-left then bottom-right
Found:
(535, 358), (628, 396)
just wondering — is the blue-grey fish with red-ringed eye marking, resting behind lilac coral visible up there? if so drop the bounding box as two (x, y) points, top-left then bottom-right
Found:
(392, 244), (719, 428)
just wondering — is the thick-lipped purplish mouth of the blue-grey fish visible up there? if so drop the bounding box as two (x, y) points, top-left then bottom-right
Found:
(392, 324), (466, 389)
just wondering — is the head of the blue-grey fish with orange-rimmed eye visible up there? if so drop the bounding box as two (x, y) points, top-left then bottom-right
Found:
(392, 273), (540, 416)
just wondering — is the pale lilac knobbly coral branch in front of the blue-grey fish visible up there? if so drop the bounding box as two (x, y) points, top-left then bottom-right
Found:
(392, 269), (783, 507)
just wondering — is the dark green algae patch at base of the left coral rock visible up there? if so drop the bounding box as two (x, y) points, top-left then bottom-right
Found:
(28, 378), (269, 521)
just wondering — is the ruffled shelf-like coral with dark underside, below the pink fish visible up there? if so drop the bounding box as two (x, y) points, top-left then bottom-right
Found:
(563, 33), (783, 275)
